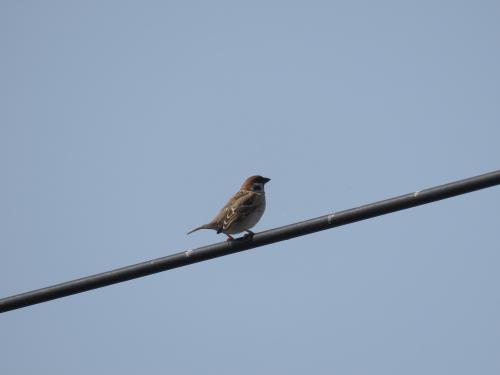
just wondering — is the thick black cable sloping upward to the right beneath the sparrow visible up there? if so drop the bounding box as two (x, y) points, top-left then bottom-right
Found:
(0, 170), (500, 313)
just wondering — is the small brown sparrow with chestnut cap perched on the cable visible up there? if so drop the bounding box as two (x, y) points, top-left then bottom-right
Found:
(188, 176), (271, 241)
